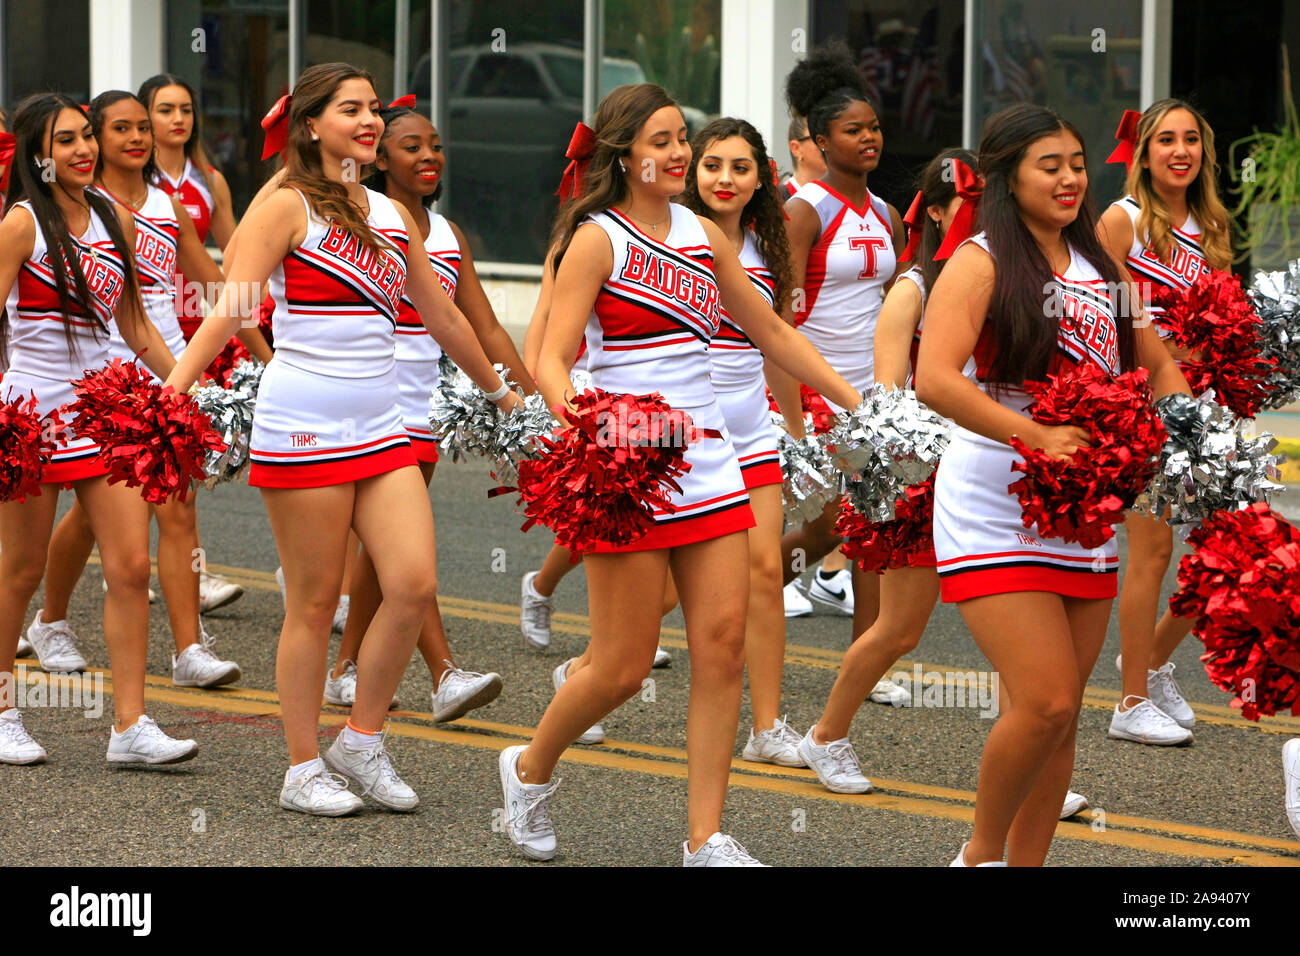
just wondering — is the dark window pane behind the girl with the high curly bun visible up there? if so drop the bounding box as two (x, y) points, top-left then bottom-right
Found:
(813, 0), (965, 211)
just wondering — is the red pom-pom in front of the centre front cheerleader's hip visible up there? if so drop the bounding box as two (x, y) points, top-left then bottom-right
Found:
(519, 389), (696, 553)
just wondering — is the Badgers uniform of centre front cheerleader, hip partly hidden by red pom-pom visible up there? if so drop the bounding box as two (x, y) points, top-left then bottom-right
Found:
(586, 204), (754, 553)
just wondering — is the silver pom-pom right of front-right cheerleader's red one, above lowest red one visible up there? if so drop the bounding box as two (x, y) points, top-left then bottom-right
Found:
(1134, 392), (1283, 529)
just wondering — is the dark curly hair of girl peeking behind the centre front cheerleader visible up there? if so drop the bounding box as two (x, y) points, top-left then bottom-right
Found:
(680, 116), (794, 310)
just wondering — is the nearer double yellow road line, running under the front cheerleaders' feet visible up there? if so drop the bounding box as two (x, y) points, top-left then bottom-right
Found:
(27, 669), (1300, 866)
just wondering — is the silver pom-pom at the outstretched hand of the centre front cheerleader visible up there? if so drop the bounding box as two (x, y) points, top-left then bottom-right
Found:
(826, 382), (949, 522)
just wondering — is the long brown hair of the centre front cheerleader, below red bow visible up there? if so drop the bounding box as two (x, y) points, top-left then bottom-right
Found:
(551, 83), (677, 271)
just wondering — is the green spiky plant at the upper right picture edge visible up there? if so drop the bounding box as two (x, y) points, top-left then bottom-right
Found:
(1229, 44), (1300, 261)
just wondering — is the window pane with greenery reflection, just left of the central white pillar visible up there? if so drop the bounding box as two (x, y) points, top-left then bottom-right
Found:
(601, 0), (723, 135)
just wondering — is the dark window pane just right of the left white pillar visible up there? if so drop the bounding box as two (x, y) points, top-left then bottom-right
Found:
(165, 0), (289, 219)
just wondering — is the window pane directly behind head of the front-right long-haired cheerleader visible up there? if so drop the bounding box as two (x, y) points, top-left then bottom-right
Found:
(975, 0), (1141, 211)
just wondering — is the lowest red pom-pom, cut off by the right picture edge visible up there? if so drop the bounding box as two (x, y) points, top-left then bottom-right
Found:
(1169, 502), (1300, 721)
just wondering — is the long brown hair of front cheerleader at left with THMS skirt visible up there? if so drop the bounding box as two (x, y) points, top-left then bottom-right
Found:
(283, 62), (393, 255)
